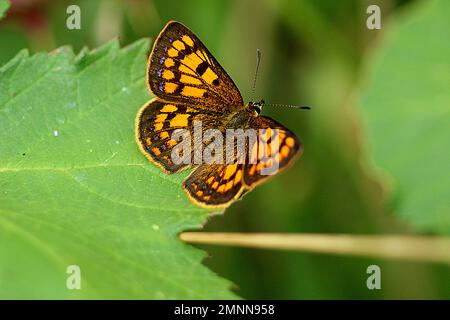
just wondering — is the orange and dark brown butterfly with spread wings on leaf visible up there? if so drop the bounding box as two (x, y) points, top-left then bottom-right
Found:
(136, 21), (302, 207)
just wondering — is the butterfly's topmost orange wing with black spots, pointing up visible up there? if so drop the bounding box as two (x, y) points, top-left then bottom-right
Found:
(147, 21), (244, 111)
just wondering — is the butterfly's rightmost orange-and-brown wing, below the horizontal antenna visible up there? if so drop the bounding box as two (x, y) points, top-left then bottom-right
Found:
(244, 116), (302, 189)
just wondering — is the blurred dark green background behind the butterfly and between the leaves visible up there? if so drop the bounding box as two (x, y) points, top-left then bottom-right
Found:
(0, 0), (450, 299)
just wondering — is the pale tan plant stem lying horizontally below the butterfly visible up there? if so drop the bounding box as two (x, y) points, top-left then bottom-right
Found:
(180, 232), (450, 265)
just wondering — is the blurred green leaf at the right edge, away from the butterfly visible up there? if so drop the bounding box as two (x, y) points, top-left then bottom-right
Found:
(360, 1), (450, 234)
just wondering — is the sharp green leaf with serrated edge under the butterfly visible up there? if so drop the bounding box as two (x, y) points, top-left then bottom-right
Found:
(0, 40), (236, 299)
